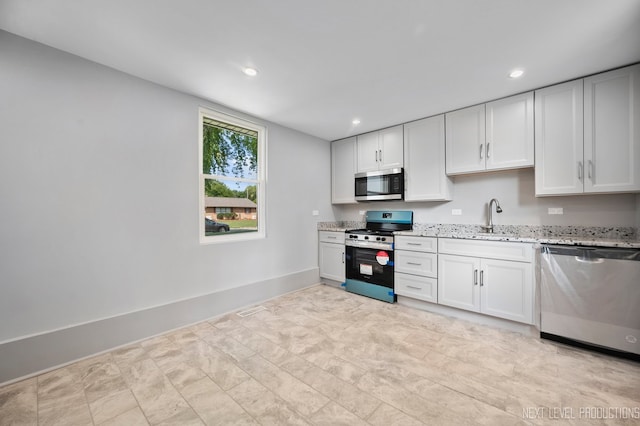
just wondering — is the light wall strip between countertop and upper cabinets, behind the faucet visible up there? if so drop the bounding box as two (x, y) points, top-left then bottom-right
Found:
(334, 169), (640, 227)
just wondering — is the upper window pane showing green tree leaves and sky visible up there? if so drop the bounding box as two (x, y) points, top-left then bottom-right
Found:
(202, 120), (258, 179)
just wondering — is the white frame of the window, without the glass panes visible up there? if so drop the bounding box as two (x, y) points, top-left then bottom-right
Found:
(198, 107), (267, 244)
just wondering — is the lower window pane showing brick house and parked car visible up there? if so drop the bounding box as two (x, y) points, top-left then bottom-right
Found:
(204, 179), (258, 236)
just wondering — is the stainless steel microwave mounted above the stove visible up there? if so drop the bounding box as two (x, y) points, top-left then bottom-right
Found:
(355, 168), (404, 201)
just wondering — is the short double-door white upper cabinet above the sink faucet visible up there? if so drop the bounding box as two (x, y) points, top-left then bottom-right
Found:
(445, 92), (534, 175)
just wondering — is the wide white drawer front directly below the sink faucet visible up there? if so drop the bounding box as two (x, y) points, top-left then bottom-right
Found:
(438, 238), (533, 262)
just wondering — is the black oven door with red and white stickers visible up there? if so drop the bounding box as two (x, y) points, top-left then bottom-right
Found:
(345, 246), (393, 289)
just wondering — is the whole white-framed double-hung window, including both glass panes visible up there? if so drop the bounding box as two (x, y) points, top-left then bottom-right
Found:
(199, 108), (266, 243)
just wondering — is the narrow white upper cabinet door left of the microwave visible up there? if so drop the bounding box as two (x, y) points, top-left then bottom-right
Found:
(331, 137), (356, 204)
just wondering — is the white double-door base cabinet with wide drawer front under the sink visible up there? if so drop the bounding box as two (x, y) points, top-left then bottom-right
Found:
(438, 238), (534, 324)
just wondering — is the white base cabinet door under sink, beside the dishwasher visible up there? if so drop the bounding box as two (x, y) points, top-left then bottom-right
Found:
(480, 259), (533, 324)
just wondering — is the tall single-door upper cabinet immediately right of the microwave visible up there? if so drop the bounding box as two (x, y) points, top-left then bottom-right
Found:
(404, 115), (452, 201)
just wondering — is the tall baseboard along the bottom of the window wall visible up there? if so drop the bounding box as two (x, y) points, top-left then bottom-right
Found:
(0, 268), (320, 386)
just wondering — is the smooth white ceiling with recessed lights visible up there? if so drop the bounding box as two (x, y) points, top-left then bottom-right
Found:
(0, 0), (640, 140)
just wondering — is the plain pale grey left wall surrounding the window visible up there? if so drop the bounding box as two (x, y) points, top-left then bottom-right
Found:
(0, 32), (334, 342)
